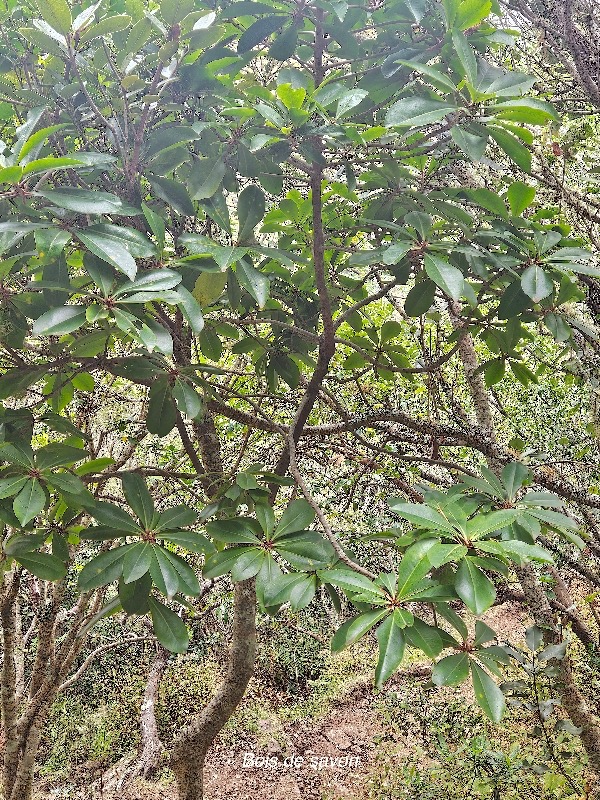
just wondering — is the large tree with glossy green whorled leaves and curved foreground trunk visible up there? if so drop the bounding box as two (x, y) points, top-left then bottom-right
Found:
(0, 0), (600, 800)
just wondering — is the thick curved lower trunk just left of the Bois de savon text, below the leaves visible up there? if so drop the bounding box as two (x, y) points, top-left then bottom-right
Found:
(171, 579), (256, 800)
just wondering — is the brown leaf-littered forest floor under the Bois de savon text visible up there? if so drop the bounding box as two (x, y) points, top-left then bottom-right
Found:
(43, 604), (524, 800)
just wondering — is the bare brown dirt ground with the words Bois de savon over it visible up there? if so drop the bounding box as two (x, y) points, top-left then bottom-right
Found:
(39, 604), (526, 800)
